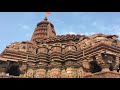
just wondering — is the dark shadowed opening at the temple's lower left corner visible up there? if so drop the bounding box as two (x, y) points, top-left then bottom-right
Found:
(6, 65), (20, 76)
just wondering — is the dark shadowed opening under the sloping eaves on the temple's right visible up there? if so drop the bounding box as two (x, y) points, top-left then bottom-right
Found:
(89, 61), (102, 73)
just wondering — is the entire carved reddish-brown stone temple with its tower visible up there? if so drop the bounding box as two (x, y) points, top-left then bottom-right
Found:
(0, 17), (120, 78)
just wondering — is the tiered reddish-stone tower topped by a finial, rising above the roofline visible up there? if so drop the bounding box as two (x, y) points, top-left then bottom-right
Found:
(31, 17), (56, 42)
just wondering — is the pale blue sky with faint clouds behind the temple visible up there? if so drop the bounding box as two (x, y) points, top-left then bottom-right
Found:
(0, 12), (120, 53)
